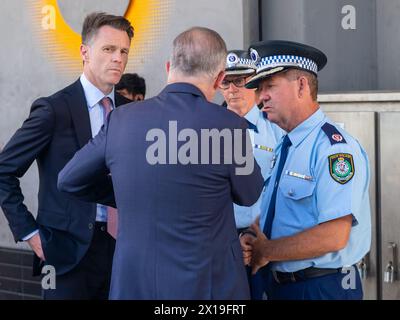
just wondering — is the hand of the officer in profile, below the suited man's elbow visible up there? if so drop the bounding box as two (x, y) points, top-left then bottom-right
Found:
(249, 222), (270, 274)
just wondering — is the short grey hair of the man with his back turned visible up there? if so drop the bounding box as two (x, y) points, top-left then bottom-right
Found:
(170, 27), (227, 77)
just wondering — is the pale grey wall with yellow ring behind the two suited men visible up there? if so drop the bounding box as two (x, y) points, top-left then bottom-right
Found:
(0, 0), (252, 248)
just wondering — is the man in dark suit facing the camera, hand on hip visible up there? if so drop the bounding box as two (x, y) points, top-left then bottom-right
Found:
(0, 13), (133, 299)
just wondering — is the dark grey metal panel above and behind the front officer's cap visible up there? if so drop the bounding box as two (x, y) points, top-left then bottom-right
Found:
(261, 0), (378, 92)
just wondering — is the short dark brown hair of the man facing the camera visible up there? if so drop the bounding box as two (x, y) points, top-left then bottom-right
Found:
(82, 12), (134, 44)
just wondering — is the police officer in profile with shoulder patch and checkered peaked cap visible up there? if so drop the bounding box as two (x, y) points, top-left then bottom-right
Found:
(241, 41), (371, 299)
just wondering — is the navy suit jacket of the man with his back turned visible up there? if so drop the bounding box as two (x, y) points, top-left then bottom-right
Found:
(58, 83), (263, 299)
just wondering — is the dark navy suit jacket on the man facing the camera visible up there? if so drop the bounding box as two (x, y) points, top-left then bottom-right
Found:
(0, 80), (129, 274)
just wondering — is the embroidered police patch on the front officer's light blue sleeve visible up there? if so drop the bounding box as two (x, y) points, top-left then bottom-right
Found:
(328, 153), (355, 184)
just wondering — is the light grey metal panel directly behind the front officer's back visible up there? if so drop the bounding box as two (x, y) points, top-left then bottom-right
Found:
(325, 112), (378, 300)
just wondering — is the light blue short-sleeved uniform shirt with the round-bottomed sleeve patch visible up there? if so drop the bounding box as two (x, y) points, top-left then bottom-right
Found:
(260, 109), (371, 272)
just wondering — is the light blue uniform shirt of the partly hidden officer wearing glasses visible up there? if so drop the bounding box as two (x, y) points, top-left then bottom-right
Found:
(233, 105), (284, 229)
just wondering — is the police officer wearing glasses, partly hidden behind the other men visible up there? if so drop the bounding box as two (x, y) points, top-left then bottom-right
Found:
(220, 50), (283, 299)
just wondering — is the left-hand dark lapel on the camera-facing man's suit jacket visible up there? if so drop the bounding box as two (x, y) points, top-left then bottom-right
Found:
(67, 79), (92, 148)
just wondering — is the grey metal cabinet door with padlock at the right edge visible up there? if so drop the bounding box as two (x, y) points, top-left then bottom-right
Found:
(379, 112), (400, 299)
